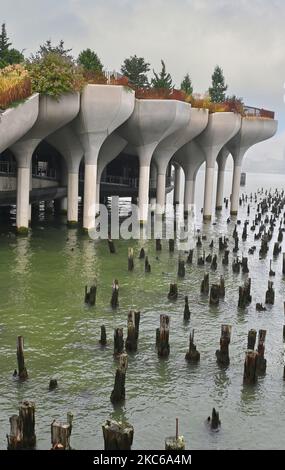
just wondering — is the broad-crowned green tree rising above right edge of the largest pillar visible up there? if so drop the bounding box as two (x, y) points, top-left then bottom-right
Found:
(121, 55), (150, 88)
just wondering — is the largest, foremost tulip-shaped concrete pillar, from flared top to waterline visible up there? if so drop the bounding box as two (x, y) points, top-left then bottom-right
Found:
(74, 85), (135, 230)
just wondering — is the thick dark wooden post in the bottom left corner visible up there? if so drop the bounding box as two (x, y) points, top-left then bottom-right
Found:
(7, 400), (36, 450)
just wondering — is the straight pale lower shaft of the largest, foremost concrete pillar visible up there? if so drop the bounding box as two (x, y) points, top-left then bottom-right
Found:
(83, 164), (97, 230)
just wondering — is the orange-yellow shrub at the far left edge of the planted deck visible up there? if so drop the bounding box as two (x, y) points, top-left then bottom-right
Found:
(0, 65), (32, 109)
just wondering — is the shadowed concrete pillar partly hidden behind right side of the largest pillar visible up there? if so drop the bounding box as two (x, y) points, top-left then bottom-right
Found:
(96, 132), (127, 204)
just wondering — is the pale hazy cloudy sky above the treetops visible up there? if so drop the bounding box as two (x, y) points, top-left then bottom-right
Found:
(0, 0), (285, 131)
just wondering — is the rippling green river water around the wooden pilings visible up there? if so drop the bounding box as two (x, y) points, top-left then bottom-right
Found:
(0, 174), (285, 449)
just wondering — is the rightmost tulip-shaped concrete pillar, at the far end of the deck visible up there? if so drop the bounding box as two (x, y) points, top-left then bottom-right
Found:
(227, 116), (278, 215)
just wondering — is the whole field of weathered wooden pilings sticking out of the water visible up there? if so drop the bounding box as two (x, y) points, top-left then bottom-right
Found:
(7, 186), (285, 450)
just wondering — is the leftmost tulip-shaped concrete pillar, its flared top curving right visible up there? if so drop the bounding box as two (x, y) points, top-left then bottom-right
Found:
(11, 93), (79, 232)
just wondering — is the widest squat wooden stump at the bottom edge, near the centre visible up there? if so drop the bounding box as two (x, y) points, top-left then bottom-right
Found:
(102, 419), (134, 450)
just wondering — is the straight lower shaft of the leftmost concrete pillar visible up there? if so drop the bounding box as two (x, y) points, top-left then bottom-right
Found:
(16, 167), (30, 233)
